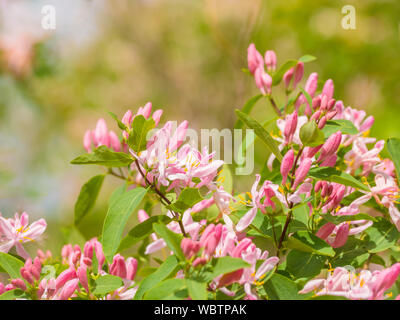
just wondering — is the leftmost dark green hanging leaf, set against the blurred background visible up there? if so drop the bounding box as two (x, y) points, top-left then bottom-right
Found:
(74, 174), (105, 225)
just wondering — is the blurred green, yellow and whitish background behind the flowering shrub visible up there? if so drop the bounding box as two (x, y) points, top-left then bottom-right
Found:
(0, 0), (400, 255)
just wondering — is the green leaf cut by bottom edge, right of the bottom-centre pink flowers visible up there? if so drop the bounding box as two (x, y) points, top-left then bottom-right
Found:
(264, 273), (304, 300)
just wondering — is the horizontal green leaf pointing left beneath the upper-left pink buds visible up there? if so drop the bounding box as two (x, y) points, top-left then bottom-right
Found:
(71, 146), (133, 168)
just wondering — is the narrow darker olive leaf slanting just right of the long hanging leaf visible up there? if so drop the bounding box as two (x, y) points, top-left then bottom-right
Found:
(118, 215), (171, 252)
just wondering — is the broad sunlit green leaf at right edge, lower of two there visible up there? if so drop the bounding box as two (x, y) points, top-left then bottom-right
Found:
(365, 217), (400, 253)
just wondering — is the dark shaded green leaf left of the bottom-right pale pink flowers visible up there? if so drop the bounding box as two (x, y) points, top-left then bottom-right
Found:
(286, 250), (324, 278)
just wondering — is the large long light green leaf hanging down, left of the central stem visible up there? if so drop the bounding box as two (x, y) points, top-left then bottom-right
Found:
(101, 187), (147, 262)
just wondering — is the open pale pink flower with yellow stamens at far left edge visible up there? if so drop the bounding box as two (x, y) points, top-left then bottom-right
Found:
(0, 212), (47, 259)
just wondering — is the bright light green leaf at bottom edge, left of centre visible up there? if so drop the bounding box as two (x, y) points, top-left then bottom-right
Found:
(144, 279), (187, 300)
